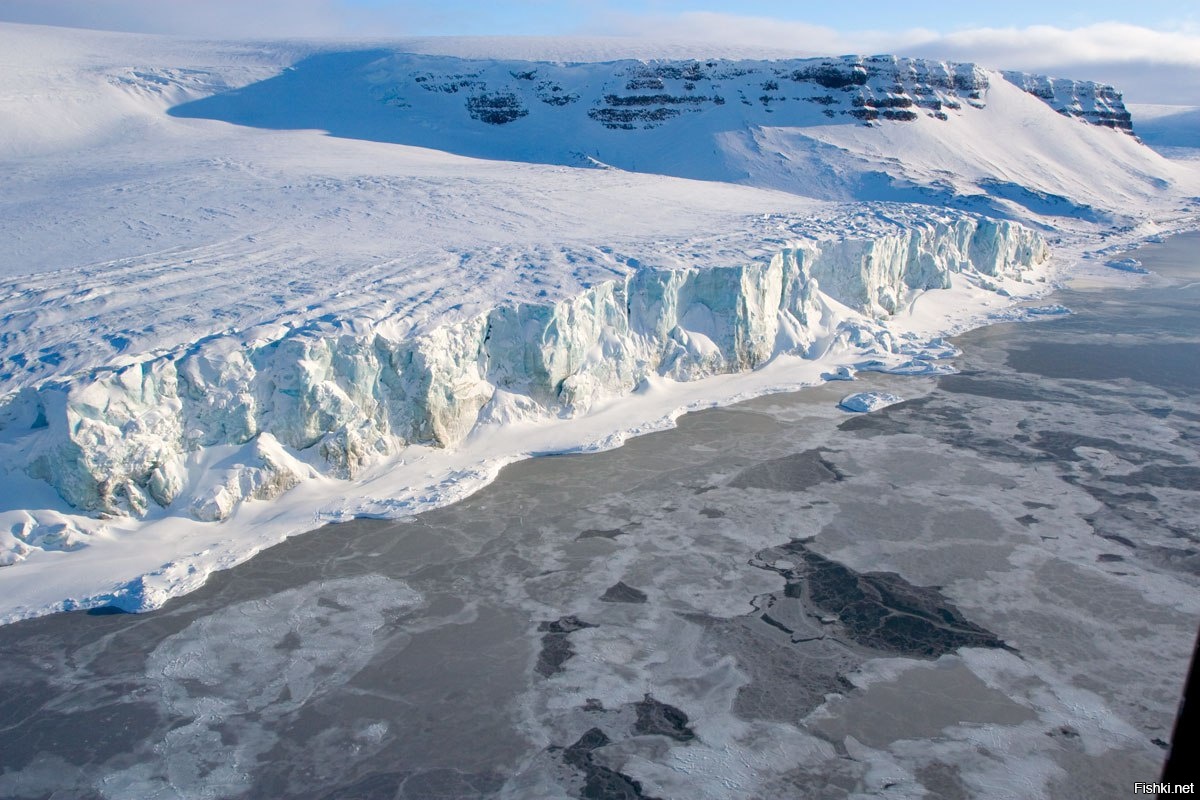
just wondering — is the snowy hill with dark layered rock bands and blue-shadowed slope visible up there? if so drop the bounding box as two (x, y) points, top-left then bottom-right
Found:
(170, 49), (1163, 219)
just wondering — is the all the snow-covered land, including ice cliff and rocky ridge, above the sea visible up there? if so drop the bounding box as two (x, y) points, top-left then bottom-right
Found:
(0, 24), (1200, 621)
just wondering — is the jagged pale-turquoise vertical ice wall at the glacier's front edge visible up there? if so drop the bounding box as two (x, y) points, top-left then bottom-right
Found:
(0, 216), (1048, 519)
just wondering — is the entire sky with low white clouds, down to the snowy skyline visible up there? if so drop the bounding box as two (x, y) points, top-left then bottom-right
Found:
(0, 0), (1200, 104)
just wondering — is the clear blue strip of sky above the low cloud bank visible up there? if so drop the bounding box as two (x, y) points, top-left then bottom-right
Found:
(0, 0), (1200, 36)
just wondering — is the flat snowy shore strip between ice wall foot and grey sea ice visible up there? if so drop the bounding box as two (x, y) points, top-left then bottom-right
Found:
(0, 219), (1188, 624)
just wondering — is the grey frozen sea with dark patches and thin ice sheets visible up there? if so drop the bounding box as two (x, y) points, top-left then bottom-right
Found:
(0, 234), (1200, 800)
